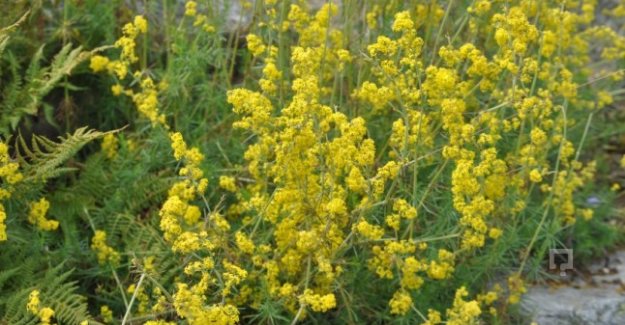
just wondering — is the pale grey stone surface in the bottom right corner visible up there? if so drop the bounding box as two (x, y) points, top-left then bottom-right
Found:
(521, 251), (625, 325)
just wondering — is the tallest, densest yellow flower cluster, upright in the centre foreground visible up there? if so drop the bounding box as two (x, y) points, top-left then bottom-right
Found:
(220, 4), (382, 313)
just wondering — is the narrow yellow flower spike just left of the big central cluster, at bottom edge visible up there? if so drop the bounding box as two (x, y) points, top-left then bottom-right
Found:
(155, 132), (245, 324)
